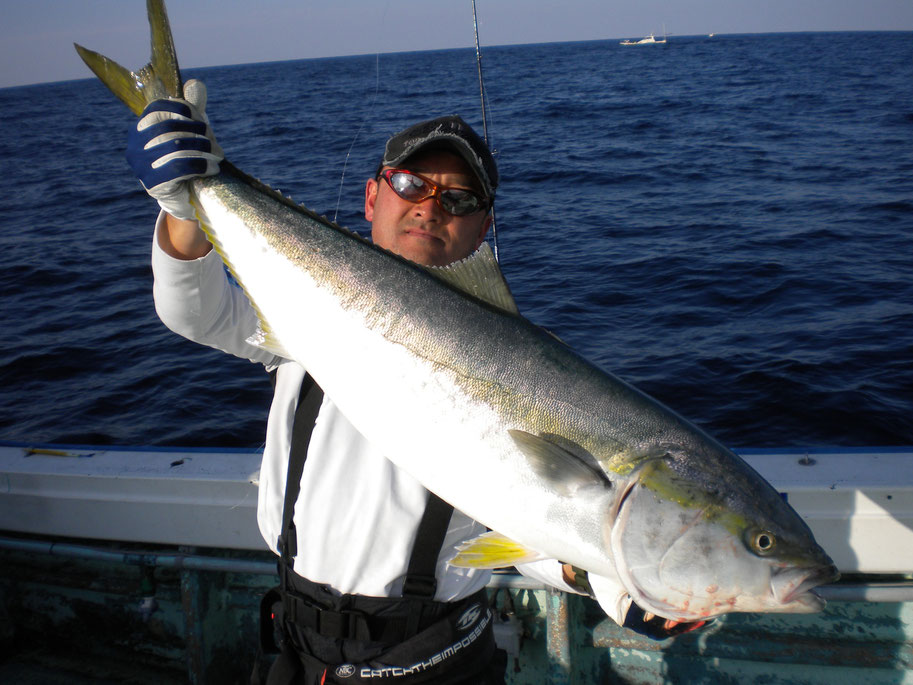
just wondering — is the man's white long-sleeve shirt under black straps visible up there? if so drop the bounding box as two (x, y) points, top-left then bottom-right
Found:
(152, 215), (575, 601)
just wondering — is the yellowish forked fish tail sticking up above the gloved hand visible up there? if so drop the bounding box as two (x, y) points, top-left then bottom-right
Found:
(74, 0), (184, 114)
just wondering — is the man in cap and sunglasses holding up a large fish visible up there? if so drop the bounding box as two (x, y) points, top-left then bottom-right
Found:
(127, 81), (700, 684)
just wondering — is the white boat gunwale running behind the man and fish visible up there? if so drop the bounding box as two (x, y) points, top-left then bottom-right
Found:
(0, 443), (913, 574)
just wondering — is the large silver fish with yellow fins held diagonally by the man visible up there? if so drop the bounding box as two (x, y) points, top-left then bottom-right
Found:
(77, 0), (836, 621)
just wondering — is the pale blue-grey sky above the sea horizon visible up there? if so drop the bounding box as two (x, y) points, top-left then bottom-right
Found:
(0, 0), (913, 87)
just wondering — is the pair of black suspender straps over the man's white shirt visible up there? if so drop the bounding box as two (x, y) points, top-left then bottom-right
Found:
(273, 372), (453, 599)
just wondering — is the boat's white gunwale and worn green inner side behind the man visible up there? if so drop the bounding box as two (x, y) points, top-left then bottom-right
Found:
(0, 444), (913, 685)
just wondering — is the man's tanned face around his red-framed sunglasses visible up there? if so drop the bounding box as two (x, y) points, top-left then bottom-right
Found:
(365, 150), (491, 266)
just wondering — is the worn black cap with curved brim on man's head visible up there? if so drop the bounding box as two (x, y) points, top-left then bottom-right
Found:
(381, 114), (498, 201)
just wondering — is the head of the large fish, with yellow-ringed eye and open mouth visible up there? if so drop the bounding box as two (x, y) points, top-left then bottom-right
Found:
(607, 448), (838, 621)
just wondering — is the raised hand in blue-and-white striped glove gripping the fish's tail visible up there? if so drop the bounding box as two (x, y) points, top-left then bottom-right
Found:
(127, 79), (225, 219)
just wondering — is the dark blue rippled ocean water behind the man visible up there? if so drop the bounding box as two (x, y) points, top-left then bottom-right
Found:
(0, 33), (913, 447)
